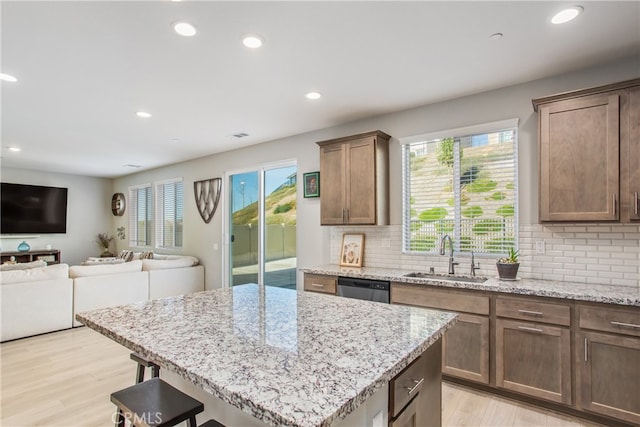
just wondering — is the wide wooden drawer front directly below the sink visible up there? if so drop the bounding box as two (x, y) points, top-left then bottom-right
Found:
(391, 283), (489, 315)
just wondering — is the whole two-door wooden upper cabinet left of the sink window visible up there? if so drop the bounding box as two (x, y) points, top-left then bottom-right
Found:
(317, 131), (391, 225)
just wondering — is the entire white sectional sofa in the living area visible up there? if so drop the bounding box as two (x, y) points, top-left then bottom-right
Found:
(0, 255), (204, 341)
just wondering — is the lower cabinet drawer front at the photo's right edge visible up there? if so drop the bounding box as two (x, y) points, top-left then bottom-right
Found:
(578, 305), (640, 337)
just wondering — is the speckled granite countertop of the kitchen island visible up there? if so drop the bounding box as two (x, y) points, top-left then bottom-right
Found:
(76, 285), (455, 426)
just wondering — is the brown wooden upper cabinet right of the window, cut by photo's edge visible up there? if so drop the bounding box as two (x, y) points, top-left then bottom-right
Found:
(533, 79), (640, 222)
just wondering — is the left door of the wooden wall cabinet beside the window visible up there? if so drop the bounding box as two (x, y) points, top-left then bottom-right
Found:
(320, 143), (346, 225)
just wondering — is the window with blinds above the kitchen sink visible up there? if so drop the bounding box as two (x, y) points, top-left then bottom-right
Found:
(402, 120), (518, 254)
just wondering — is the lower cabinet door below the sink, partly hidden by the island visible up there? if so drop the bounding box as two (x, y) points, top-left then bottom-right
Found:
(442, 314), (489, 384)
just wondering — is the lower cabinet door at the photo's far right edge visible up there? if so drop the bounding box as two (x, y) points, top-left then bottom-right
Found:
(576, 332), (640, 425)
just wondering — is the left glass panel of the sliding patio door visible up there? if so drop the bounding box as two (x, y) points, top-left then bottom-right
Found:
(229, 171), (260, 286)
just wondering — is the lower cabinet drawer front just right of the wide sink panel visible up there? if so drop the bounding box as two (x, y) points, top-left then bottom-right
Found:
(496, 297), (571, 326)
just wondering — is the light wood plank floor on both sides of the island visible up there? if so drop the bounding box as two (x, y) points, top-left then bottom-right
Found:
(0, 327), (595, 427)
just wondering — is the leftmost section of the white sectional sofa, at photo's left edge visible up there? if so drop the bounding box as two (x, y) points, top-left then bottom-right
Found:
(0, 264), (73, 341)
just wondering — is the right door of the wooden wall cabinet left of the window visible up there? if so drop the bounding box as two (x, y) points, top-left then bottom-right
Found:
(346, 137), (376, 225)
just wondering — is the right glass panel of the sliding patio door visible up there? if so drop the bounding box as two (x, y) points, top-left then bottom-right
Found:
(262, 165), (297, 289)
